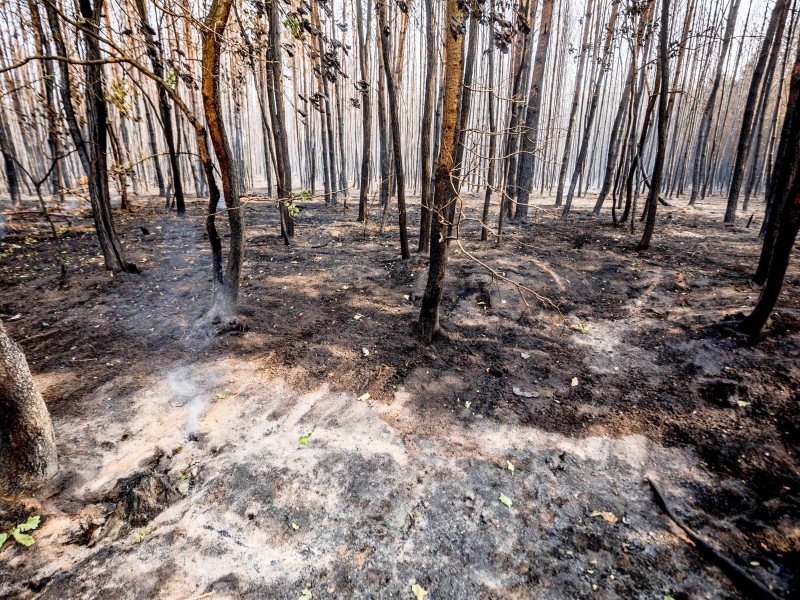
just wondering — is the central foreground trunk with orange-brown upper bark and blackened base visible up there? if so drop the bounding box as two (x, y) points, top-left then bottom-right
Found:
(419, 0), (464, 344)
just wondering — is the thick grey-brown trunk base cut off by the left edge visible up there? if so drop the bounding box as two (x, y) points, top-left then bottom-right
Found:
(0, 324), (58, 495)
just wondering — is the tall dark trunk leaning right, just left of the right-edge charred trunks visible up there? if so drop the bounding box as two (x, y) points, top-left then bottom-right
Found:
(725, 0), (789, 223)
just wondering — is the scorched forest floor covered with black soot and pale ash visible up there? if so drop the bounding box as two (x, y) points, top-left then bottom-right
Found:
(0, 192), (800, 600)
